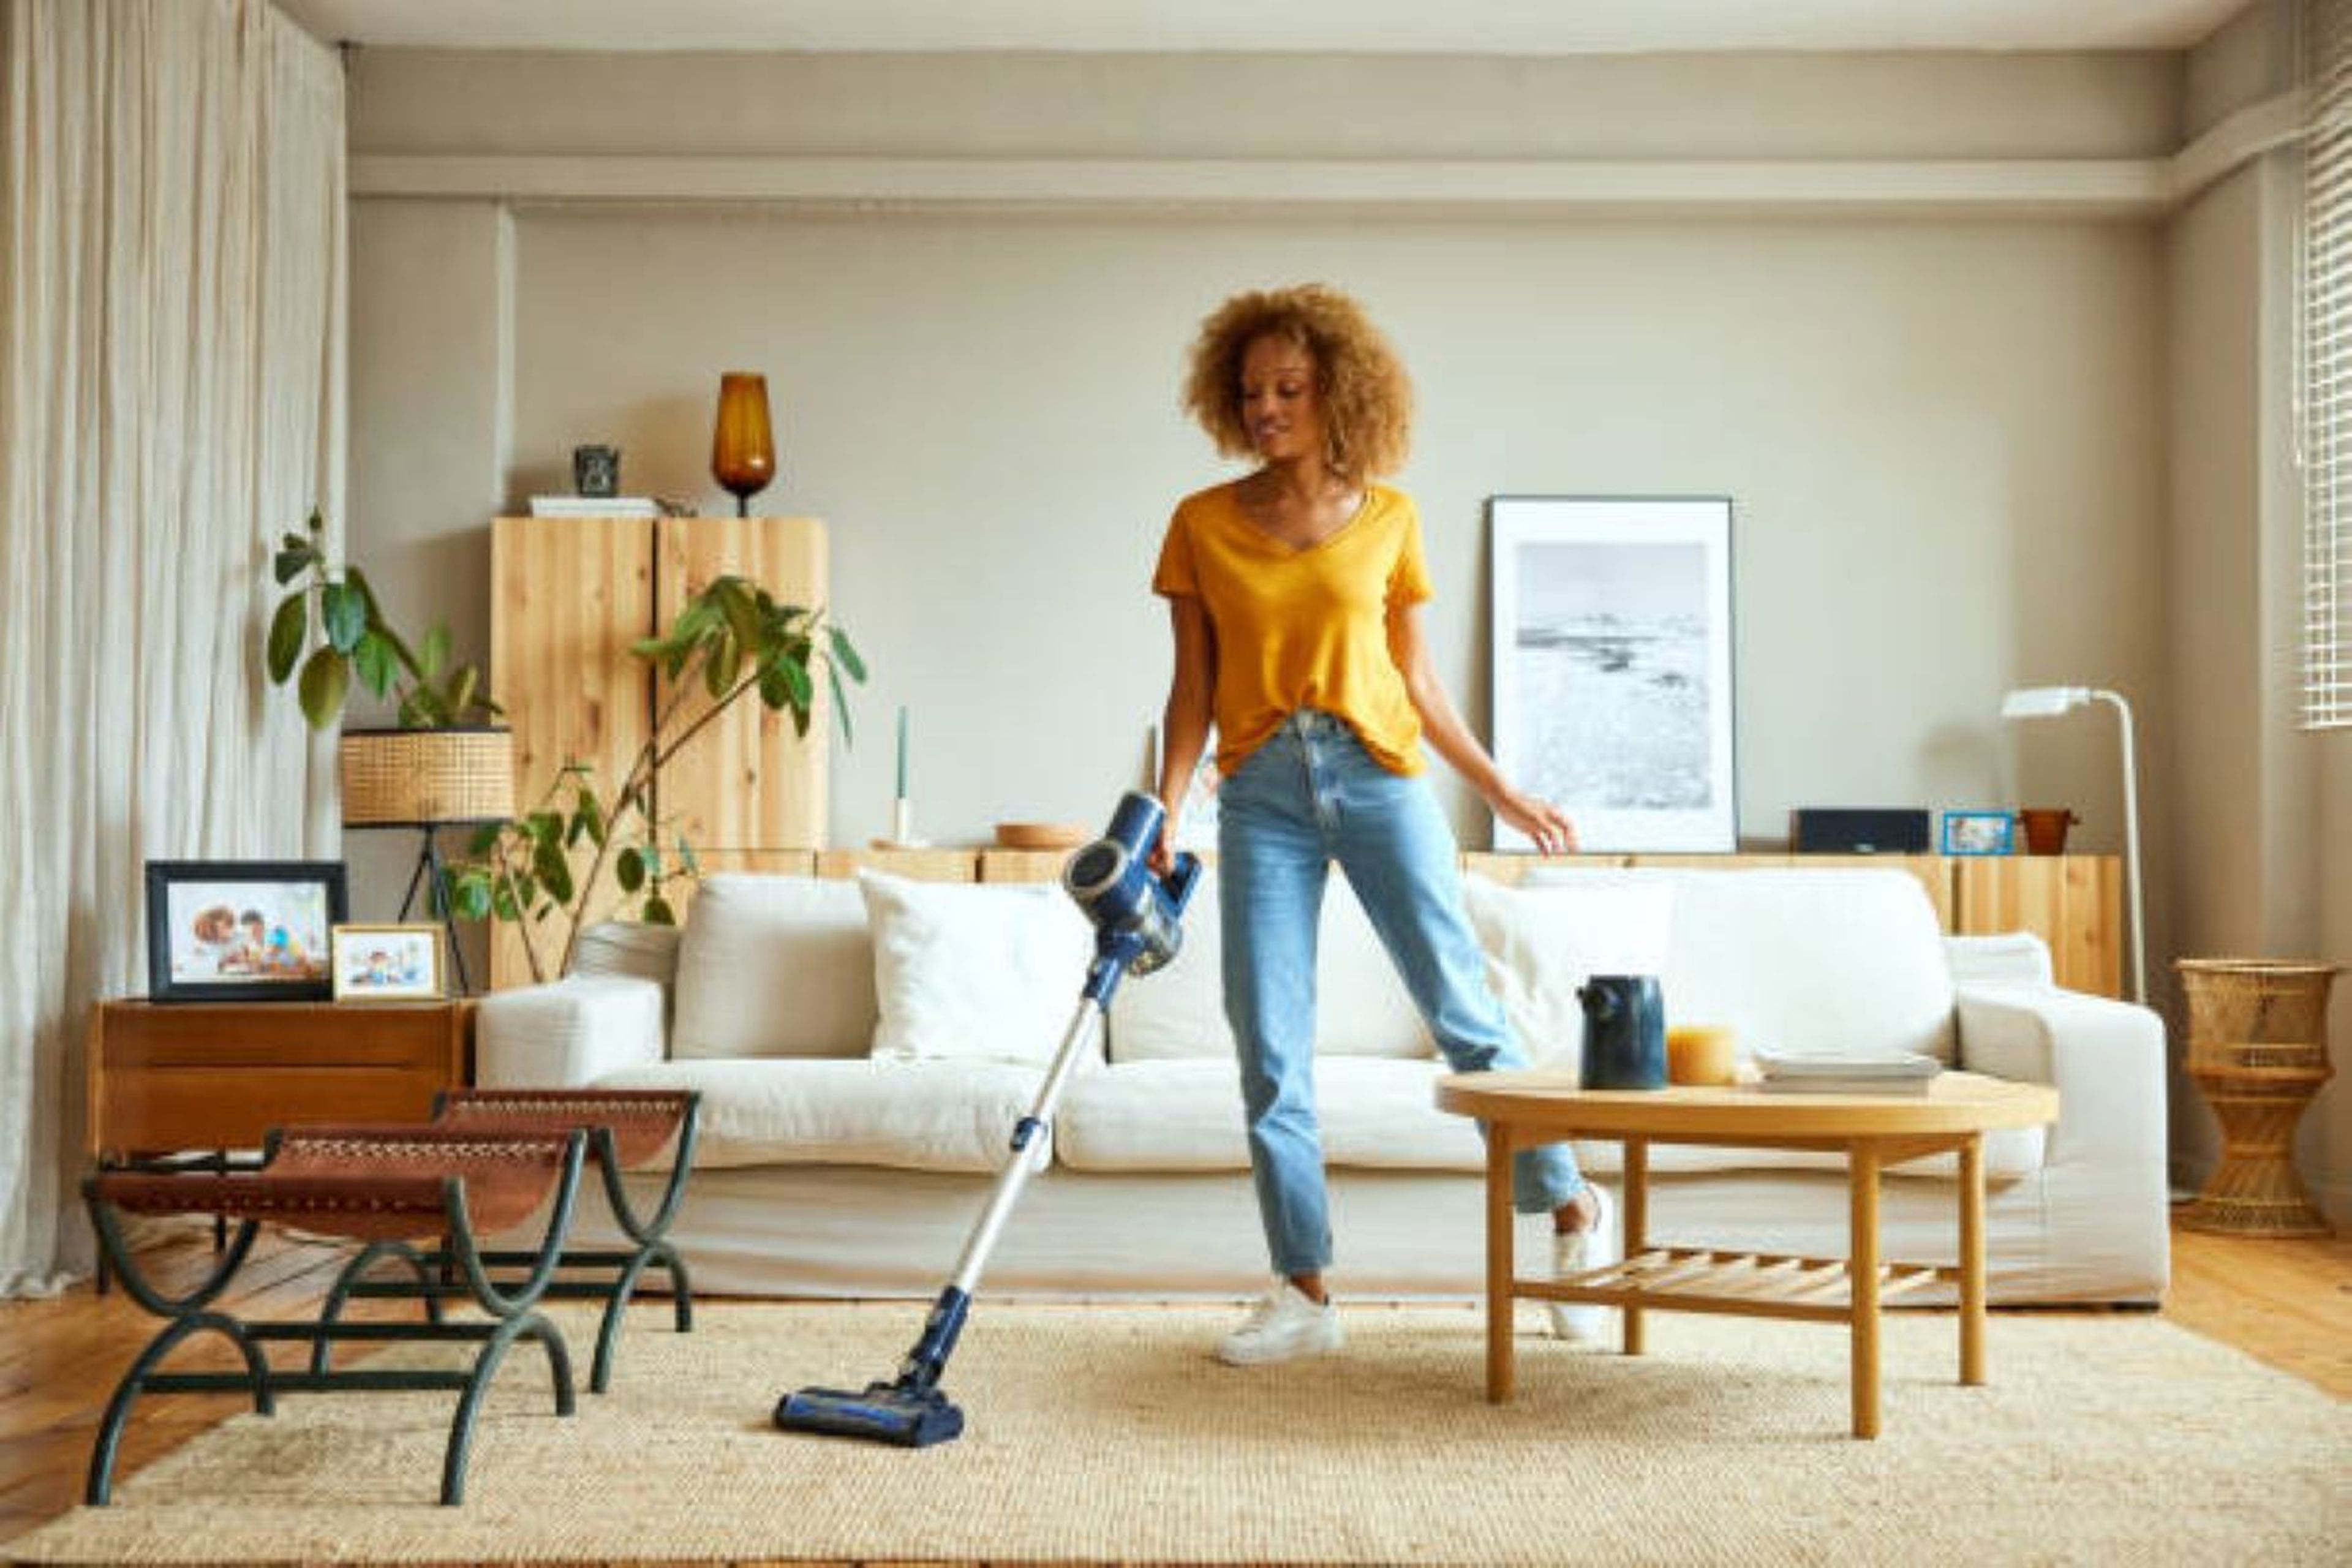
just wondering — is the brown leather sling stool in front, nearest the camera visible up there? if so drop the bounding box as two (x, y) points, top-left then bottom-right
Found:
(82, 1126), (588, 1507)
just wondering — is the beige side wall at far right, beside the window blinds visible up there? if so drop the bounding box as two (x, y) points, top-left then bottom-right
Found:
(2154, 2), (2352, 1223)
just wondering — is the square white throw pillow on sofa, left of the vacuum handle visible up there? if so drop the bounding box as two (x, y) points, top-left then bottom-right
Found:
(859, 872), (1098, 1067)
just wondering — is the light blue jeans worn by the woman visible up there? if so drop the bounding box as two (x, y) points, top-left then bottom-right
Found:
(1216, 707), (1585, 1274)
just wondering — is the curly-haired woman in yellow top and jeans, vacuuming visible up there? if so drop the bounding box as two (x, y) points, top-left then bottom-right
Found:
(1153, 284), (1609, 1363)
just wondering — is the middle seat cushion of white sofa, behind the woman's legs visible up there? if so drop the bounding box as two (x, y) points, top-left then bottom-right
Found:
(1054, 1055), (1487, 1170)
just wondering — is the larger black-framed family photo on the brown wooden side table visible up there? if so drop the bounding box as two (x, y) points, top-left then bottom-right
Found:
(146, 861), (348, 1001)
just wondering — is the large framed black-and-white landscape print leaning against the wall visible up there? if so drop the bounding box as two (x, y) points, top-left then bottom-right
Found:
(1487, 496), (1738, 853)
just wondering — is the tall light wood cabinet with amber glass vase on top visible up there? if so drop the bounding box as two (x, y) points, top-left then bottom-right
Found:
(489, 517), (832, 987)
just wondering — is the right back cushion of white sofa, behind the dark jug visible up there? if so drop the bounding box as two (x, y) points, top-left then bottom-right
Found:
(1529, 867), (1954, 1065)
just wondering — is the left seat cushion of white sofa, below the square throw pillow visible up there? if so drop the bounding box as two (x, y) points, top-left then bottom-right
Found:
(597, 1058), (1042, 1170)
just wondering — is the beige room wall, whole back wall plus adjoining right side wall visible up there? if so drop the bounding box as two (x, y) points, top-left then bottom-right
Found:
(336, 43), (2352, 1197)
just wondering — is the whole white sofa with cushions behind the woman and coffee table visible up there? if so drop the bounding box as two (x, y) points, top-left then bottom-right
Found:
(478, 865), (2168, 1302)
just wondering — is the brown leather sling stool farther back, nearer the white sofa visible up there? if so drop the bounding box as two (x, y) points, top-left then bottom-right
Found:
(320, 1088), (701, 1394)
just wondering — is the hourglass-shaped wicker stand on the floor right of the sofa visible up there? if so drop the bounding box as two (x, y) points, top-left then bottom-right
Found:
(2173, 959), (2335, 1237)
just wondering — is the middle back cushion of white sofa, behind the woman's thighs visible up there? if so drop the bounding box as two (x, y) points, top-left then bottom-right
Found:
(1110, 867), (1437, 1063)
